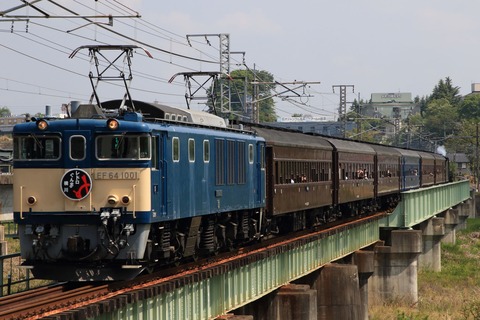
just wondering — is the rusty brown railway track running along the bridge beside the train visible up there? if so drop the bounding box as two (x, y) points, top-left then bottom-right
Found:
(0, 213), (386, 320)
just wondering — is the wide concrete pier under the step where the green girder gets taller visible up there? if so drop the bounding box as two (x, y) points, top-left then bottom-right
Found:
(368, 230), (422, 304)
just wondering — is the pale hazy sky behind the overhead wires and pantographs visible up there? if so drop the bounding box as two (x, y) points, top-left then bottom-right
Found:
(0, 0), (480, 120)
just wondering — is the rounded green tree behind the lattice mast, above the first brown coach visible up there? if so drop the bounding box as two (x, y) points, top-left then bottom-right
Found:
(208, 70), (277, 122)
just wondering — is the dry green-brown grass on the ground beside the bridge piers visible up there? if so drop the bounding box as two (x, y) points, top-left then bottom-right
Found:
(369, 219), (480, 320)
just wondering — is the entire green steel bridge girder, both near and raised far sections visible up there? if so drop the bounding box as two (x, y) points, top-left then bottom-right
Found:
(88, 181), (470, 320)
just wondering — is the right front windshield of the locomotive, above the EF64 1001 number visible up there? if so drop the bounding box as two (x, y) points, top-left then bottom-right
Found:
(96, 134), (150, 160)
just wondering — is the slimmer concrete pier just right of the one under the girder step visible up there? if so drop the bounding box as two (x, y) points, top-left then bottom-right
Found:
(418, 217), (445, 272)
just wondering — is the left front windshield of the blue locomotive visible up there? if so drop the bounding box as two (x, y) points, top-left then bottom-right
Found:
(13, 135), (60, 160)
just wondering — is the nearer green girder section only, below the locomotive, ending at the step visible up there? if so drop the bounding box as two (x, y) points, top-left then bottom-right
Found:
(103, 219), (380, 320)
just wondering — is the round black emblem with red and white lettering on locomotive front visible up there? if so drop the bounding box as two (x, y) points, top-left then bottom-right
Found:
(60, 169), (92, 200)
